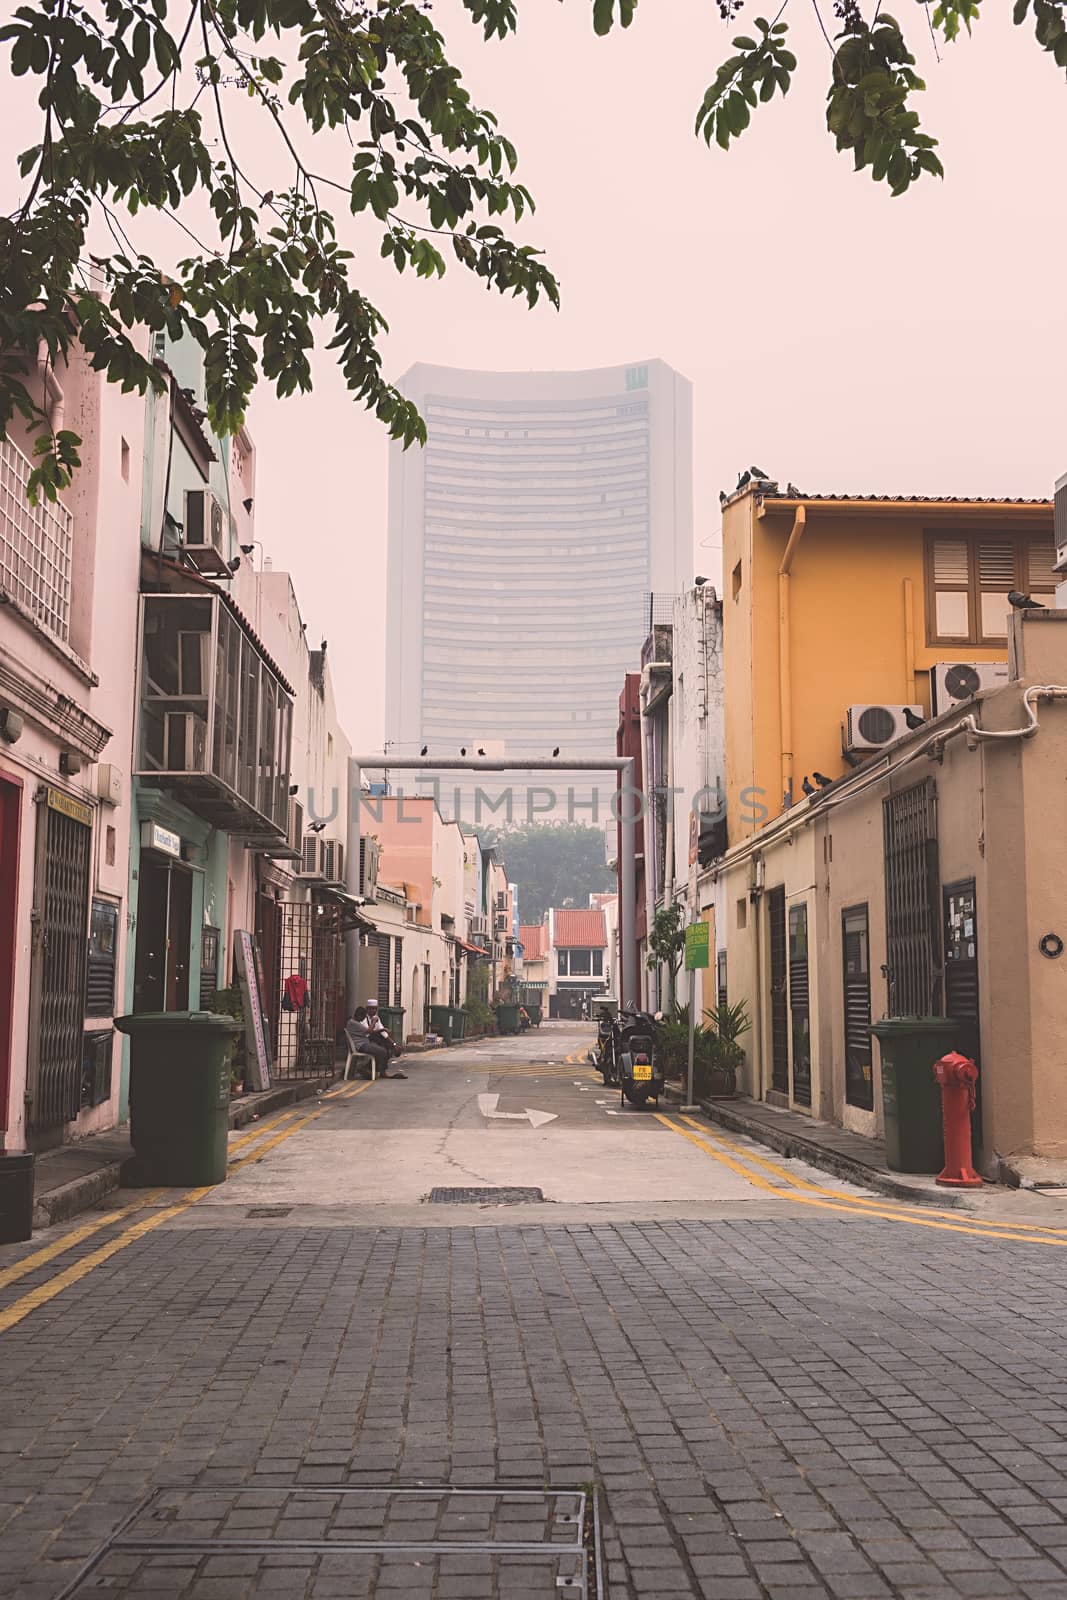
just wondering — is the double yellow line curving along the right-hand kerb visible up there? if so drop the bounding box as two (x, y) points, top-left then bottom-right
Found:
(654, 1112), (1067, 1250)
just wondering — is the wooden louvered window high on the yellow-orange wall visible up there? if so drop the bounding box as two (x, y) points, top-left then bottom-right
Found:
(926, 531), (1056, 645)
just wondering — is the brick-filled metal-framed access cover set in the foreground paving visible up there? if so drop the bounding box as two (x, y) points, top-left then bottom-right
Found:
(58, 1485), (606, 1600)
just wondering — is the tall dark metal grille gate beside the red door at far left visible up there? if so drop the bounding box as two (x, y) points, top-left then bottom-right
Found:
(26, 789), (93, 1136)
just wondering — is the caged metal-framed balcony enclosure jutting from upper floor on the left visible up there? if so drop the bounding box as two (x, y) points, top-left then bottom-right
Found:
(136, 594), (293, 845)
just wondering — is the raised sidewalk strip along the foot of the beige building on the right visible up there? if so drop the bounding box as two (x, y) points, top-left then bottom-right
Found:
(668, 1091), (961, 1208)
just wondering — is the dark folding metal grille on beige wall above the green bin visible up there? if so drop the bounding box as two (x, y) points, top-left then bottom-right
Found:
(881, 778), (941, 1016)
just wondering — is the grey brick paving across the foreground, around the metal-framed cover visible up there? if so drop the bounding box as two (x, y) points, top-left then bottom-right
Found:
(0, 1205), (1067, 1600)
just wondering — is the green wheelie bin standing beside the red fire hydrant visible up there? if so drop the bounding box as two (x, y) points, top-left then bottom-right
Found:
(870, 1016), (960, 1173)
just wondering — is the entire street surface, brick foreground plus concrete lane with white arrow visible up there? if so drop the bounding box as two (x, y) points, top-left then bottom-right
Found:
(0, 1026), (1067, 1600)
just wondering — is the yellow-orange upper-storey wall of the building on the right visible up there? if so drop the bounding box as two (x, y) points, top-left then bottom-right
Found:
(723, 496), (1053, 843)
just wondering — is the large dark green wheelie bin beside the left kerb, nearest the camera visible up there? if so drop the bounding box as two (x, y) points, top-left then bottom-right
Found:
(115, 1011), (242, 1187)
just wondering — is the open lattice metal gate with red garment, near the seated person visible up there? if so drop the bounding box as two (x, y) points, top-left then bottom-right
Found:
(274, 901), (344, 1078)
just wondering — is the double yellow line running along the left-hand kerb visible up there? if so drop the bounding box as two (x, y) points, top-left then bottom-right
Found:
(0, 1082), (371, 1333)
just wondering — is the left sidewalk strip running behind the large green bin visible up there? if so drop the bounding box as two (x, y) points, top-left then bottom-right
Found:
(34, 1072), (336, 1227)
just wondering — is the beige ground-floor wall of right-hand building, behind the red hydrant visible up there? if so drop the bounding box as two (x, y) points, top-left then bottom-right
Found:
(709, 611), (1067, 1176)
